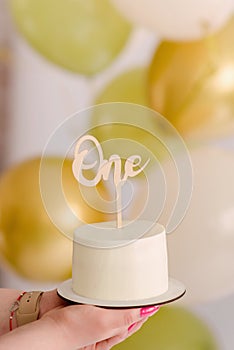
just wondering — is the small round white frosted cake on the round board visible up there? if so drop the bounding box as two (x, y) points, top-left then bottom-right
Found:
(72, 220), (168, 301)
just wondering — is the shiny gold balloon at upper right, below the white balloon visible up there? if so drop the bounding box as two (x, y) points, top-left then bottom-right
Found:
(149, 19), (234, 138)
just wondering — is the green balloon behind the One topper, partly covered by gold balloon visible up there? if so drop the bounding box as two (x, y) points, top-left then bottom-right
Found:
(90, 67), (168, 165)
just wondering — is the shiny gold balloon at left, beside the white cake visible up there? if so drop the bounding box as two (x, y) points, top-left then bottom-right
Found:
(0, 158), (108, 281)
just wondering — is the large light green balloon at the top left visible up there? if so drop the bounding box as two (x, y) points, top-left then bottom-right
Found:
(11, 0), (131, 75)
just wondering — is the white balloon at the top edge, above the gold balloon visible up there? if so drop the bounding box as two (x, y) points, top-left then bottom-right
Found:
(112, 0), (233, 40)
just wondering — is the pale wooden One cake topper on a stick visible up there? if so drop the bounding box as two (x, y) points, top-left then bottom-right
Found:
(72, 135), (150, 228)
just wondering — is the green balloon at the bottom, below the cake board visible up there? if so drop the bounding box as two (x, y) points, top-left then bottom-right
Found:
(114, 306), (218, 350)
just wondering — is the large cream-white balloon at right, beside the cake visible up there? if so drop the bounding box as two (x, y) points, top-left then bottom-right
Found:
(165, 146), (234, 303)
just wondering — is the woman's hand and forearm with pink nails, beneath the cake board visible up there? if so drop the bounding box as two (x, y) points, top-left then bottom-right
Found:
(0, 290), (158, 350)
